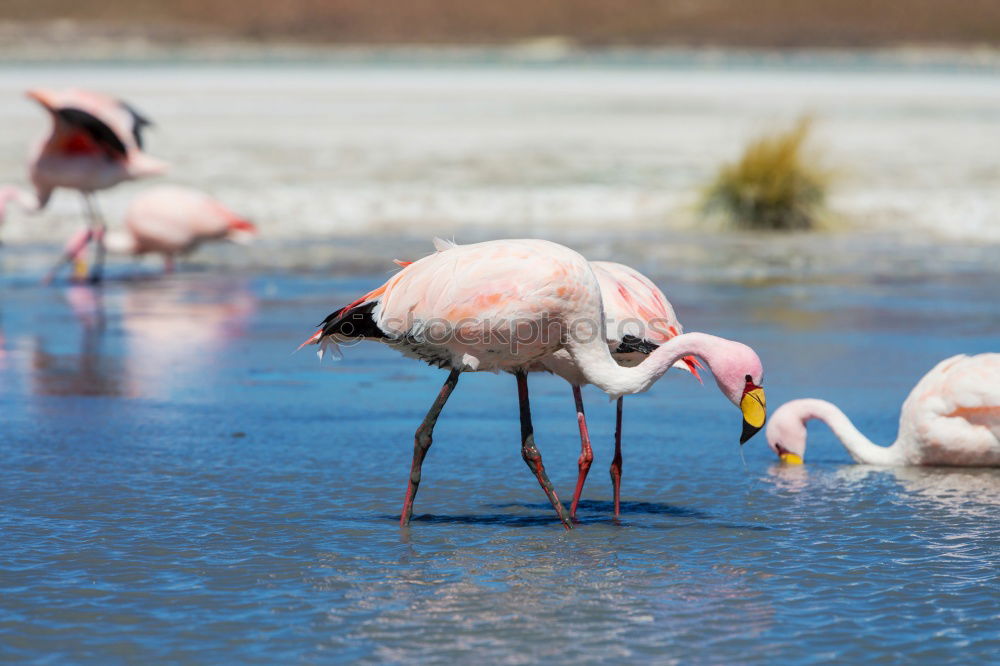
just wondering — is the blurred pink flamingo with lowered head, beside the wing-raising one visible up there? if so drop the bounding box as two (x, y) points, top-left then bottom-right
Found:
(47, 185), (257, 279)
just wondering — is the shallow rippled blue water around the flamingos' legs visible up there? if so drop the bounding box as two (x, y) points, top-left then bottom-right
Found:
(0, 273), (1000, 664)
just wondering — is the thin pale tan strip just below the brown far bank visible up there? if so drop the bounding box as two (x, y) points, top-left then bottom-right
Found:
(0, 20), (1000, 69)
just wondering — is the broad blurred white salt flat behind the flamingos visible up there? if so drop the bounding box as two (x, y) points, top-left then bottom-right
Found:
(0, 56), (1000, 275)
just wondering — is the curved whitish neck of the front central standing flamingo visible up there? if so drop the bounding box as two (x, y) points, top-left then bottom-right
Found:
(568, 333), (738, 400)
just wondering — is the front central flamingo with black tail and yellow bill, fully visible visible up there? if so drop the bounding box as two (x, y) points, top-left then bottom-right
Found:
(302, 240), (765, 529)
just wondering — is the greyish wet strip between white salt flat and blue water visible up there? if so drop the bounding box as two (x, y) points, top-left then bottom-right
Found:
(0, 228), (1000, 286)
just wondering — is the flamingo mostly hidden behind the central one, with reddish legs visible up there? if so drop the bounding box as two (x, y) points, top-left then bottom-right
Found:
(541, 261), (701, 520)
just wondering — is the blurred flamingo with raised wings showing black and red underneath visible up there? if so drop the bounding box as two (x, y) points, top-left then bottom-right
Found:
(0, 88), (166, 282)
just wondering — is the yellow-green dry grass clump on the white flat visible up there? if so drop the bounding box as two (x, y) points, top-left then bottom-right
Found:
(702, 118), (830, 231)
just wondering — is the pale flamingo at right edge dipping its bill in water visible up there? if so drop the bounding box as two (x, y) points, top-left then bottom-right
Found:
(767, 354), (1000, 467)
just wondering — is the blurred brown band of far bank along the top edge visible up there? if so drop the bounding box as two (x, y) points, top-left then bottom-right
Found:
(0, 0), (1000, 48)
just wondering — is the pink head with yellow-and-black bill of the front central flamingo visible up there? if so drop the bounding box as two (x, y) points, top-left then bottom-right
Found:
(710, 340), (767, 444)
